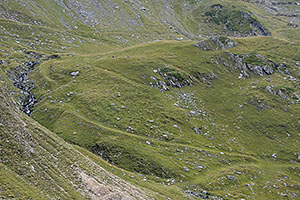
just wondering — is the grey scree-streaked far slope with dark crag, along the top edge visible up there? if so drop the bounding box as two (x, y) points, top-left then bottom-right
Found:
(0, 0), (288, 41)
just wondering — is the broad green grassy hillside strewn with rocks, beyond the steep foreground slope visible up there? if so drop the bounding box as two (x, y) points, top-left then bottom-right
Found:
(19, 37), (300, 199)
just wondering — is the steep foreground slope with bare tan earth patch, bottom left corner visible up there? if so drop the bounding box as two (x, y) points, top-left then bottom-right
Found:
(0, 82), (151, 199)
